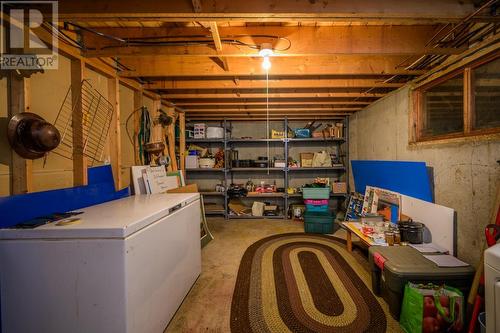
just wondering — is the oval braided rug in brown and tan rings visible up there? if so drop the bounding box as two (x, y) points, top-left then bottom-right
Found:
(231, 233), (387, 333)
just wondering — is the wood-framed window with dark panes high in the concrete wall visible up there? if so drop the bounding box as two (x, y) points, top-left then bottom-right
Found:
(413, 52), (500, 141)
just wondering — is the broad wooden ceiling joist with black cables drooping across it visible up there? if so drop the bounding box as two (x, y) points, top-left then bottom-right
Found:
(81, 22), (465, 57)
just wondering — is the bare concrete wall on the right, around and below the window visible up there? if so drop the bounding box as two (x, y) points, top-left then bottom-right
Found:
(349, 86), (500, 264)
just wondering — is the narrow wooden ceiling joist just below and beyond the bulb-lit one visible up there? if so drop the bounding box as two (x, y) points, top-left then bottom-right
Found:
(144, 77), (402, 91)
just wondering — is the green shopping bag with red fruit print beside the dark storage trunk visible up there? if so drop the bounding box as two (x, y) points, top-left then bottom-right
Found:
(399, 283), (464, 333)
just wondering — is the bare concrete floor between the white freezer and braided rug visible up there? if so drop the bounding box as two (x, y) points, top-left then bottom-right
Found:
(165, 218), (399, 333)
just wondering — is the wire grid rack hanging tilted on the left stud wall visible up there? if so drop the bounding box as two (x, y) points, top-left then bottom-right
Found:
(53, 80), (114, 166)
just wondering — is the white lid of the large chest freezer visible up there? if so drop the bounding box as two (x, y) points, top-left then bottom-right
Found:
(0, 193), (200, 240)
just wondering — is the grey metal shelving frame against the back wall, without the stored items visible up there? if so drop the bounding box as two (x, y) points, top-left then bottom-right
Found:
(182, 117), (349, 219)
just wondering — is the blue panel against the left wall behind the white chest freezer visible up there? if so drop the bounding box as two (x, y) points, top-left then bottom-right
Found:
(0, 165), (130, 228)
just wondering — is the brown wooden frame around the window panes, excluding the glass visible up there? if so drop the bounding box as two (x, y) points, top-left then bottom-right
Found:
(410, 51), (500, 143)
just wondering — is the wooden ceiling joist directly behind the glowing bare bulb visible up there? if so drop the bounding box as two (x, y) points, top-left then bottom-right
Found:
(121, 55), (425, 78)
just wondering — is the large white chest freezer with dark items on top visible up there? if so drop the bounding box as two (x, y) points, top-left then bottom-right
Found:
(0, 193), (201, 333)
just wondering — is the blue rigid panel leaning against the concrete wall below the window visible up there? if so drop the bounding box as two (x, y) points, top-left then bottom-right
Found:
(351, 160), (433, 202)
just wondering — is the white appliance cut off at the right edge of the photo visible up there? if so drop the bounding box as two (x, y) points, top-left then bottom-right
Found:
(484, 244), (500, 333)
